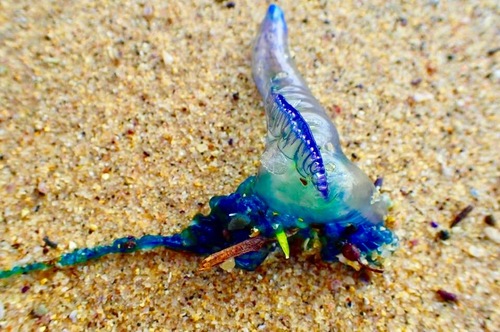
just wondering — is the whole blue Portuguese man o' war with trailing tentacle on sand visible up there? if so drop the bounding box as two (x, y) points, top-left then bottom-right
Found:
(0, 5), (398, 278)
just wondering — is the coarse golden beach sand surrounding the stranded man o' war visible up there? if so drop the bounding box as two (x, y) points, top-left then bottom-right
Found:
(0, 0), (500, 331)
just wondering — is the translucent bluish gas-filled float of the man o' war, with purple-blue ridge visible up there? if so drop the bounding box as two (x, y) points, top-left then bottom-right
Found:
(252, 5), (388, 228)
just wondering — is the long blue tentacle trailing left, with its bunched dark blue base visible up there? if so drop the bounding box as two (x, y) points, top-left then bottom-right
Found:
(0, 177), (296, 279)
